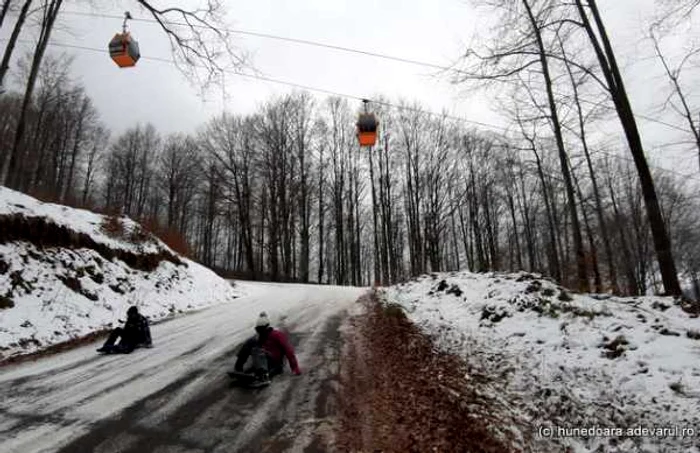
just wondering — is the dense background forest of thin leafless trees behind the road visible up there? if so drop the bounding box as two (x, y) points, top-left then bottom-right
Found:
(0, 52), (700, 294)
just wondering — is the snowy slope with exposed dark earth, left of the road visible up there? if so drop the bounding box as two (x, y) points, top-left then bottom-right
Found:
(0, 187), (238, 359)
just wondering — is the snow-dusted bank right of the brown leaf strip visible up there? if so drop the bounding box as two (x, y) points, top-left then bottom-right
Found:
(381, 272), (700, 452)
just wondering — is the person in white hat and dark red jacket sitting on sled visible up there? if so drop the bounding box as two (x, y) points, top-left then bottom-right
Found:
(229, 312), (301, 384)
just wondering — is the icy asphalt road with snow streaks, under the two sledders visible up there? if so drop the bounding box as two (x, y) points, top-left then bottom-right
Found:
(0, 282), (364, 453)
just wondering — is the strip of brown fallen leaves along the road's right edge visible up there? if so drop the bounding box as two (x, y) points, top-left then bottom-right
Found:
(337, 296), (522, 453)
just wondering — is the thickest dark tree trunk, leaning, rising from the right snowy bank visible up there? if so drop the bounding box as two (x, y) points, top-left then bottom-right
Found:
(575, 0), (682, 296)
